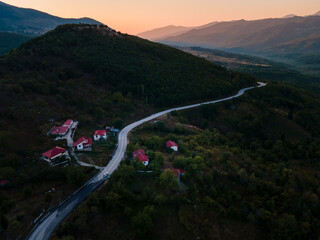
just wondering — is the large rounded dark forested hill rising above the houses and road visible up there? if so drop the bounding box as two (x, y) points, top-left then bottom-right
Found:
(1, 25), (256, 106)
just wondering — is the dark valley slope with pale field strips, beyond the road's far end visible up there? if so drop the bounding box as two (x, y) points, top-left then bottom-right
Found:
(177, 47), (320, 92)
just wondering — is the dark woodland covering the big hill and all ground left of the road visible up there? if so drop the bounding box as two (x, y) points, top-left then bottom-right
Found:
(0, 25), (256, 238)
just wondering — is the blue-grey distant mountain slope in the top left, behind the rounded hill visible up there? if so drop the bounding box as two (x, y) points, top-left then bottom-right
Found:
(0, 2), (100, 35)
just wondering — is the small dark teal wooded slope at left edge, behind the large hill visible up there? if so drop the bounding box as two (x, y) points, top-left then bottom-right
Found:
(0, 32), (31, 56)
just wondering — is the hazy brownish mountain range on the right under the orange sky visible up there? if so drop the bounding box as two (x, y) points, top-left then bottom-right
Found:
(139, 11), (320, 74)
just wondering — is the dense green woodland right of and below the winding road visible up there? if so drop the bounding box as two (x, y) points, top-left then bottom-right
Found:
(53, 83), (320, 240)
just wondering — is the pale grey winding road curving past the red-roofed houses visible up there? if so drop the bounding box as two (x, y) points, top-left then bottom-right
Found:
(27, 82), (267, 240)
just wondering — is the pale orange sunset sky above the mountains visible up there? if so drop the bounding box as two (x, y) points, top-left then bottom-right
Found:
(0, 0), (320, 34)
